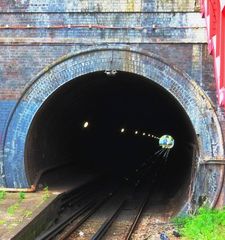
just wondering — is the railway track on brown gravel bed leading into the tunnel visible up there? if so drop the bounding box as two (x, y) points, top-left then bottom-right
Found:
(37, 179), (149, 240)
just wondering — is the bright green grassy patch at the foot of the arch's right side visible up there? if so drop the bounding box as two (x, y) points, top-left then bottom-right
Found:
(173, 207), (225, 240)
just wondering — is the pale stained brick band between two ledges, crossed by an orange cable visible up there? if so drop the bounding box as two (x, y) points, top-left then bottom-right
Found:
(0, 13), (206, 45)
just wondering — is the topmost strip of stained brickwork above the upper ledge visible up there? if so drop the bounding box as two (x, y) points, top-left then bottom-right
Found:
(0, 0), (199, 12)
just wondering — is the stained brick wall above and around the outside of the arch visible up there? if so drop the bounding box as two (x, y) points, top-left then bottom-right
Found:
(0, 0), (225, 206)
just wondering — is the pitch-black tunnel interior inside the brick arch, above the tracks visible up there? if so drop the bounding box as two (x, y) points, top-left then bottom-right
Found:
(25, 72), (195, 204)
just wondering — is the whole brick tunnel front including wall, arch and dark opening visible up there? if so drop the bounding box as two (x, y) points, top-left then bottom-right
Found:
(0, 3), (225, 236)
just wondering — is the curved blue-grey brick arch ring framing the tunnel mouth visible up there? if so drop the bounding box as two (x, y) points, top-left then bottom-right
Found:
(4, 48), (224, 212)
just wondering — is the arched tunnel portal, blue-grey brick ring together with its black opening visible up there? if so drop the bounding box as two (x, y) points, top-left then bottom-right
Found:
(4, 48), (223, 213)
